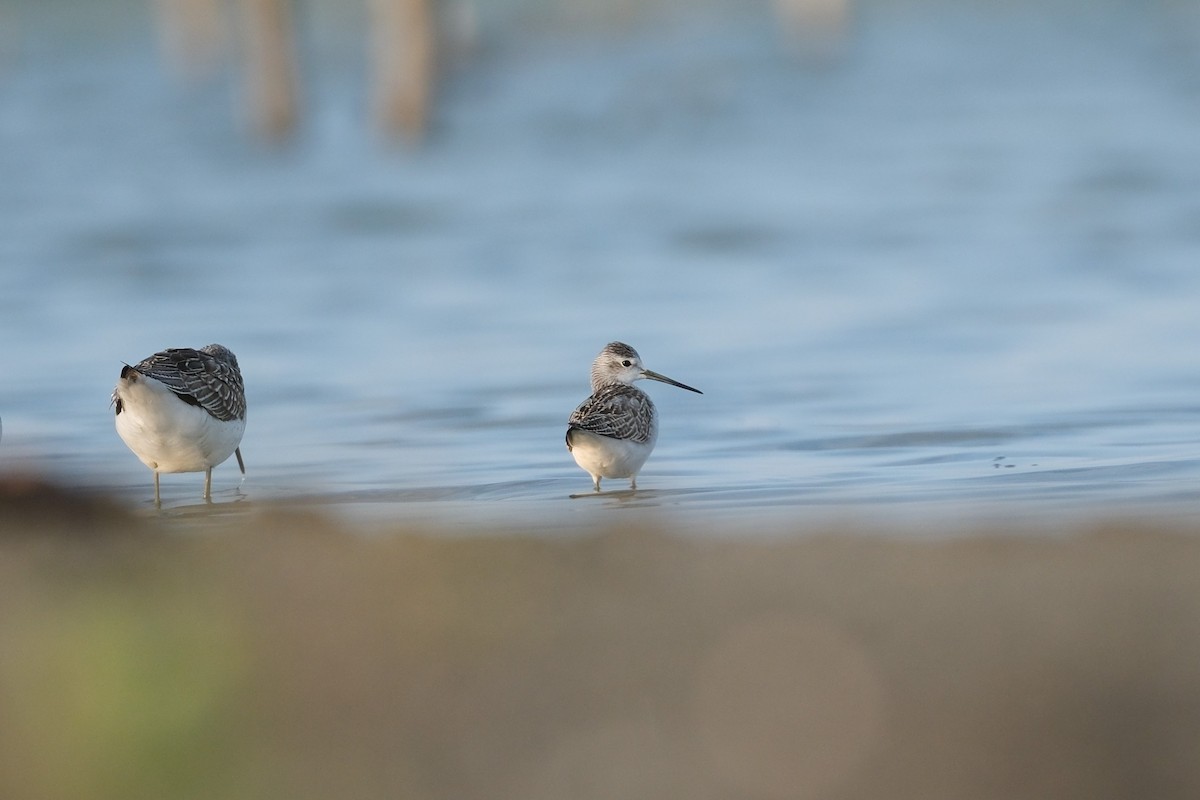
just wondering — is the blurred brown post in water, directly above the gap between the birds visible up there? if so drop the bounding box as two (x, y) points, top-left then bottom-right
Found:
(370, 0), (437, 140)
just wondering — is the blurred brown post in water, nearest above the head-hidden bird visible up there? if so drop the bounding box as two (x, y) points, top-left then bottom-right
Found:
(241, 0), (299, 139)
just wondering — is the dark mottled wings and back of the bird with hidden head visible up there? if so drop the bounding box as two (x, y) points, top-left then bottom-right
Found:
(133, 345), (246, 421)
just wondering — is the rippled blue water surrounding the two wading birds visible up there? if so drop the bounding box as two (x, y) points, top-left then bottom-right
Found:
(0, 0), (1200, 530)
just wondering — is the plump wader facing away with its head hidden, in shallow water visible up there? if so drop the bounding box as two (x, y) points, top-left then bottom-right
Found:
(113, 344), (246, 505)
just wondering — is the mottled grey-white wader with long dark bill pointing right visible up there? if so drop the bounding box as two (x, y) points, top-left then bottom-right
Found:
(566, 342), (703, 492)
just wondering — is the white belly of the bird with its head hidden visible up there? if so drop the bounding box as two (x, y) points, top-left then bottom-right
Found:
(116, 375), (246, 473)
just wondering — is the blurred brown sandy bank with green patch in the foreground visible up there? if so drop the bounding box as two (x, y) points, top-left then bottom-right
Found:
(0, 481), (1200, 800)
